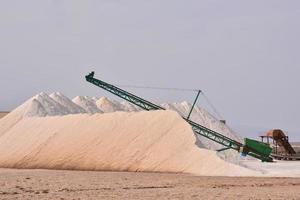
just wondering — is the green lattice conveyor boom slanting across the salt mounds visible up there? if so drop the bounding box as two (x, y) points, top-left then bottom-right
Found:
(85, 72), (272, 160)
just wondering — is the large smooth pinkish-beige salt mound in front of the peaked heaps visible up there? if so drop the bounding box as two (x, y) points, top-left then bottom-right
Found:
(0, 111), (258, 176)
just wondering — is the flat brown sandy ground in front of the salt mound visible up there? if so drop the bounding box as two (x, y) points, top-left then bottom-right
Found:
(0, 169), (300, 200)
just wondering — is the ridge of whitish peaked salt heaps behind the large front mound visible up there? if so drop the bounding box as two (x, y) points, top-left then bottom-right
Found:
(0, 92), (241, 163)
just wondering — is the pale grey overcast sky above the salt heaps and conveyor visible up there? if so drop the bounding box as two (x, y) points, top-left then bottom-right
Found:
(0, 0), (300, 140)
